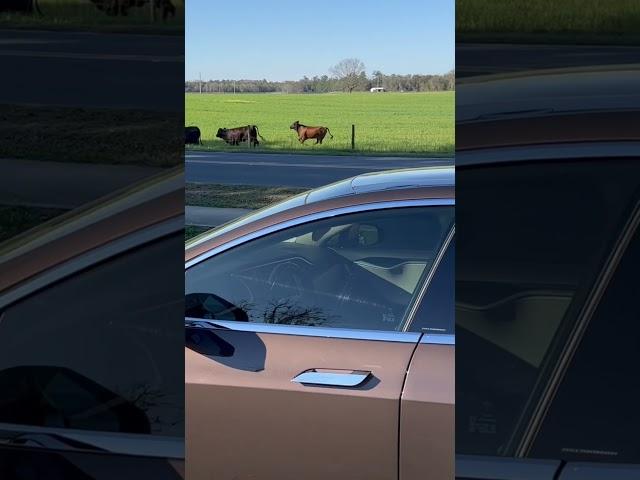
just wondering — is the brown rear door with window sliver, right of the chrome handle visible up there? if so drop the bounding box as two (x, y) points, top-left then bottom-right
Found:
(399, 231), (455, 480)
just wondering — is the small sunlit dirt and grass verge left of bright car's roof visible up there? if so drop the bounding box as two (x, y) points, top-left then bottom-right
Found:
(185, 183), (307, 208)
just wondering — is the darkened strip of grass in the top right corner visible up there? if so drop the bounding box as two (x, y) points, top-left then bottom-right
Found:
(456, 0), (640, 39)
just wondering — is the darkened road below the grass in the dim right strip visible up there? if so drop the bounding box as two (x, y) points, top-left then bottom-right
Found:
(456, 43), (640, 77)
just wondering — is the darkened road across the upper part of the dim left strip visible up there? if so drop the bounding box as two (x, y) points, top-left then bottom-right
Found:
(0, 30), (184, 110)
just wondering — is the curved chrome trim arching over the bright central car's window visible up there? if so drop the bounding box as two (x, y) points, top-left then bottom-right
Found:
(185, 198), (455, 270)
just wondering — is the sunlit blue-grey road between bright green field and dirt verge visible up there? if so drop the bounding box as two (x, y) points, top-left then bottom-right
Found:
(185, 151), (453, 188)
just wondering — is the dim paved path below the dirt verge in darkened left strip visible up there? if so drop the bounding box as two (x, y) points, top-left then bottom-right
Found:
(0, 159), (162, 209)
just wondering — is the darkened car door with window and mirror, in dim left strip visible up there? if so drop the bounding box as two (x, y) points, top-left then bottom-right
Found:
(0, 231), (184, 480)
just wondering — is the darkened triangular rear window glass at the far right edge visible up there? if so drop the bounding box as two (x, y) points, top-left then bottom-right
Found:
(531, 216), (640, 463)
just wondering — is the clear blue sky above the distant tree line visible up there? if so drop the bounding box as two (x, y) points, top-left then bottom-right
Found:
(185, 0), (455, 80)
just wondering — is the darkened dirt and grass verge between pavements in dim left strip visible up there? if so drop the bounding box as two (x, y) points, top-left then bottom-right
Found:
(0, 105), (184, 167)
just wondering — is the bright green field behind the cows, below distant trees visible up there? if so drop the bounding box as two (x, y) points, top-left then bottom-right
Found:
(185, 92), (455, 155)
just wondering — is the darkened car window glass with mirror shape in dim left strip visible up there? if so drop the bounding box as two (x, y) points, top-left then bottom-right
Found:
(0, 235), (184, 437)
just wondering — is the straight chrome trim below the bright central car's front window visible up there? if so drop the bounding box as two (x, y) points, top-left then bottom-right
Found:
(185, 317), (422, 344)
